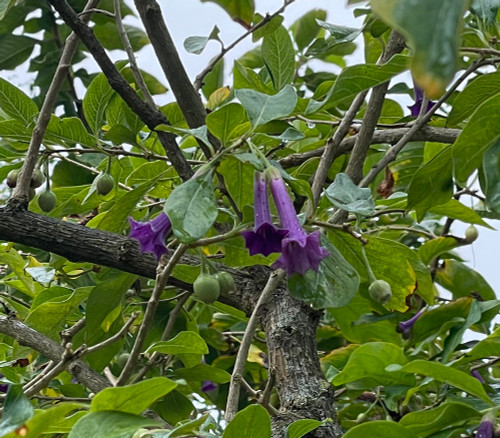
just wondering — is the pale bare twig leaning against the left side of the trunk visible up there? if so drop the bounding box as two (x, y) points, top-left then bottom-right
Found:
(225, 269), (285, 421)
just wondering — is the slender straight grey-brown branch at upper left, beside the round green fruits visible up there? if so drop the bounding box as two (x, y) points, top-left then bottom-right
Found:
(12, 0), (99, 203)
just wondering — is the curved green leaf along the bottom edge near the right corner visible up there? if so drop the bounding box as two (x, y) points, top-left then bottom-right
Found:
(399, 403), (482, 436)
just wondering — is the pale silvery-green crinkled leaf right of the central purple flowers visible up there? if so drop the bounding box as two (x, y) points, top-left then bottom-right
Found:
(325, 173), (375, 216)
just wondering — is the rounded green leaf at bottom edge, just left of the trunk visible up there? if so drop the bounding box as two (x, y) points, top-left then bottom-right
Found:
(222, 405), (271, 438)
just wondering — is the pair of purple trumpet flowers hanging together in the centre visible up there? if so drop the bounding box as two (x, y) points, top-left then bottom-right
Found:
(242, 168), (330, 276)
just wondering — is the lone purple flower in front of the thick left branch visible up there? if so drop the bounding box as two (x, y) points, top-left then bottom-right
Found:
(128, 212), (172, 260)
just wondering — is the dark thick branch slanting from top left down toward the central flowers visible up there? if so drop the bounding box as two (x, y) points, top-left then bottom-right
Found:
(49, 0), (193, 180)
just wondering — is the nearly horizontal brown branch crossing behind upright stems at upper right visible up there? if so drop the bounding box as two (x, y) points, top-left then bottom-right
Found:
(279, 125), (462, 169)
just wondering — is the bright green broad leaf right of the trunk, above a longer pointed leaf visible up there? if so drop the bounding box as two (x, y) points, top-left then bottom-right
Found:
(332, 342), (415, 389)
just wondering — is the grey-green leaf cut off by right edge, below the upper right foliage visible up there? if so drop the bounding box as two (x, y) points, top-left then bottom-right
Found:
(479, 137), (500, 213)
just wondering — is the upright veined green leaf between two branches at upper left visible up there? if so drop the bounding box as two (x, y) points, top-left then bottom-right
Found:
(82, 73), (114, 137)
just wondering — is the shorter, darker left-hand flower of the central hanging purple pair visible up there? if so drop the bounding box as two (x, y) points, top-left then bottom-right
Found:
(241, 172), (288, 256)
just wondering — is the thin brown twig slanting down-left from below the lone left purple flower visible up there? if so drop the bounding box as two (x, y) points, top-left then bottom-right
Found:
(116, 244), (187, 386)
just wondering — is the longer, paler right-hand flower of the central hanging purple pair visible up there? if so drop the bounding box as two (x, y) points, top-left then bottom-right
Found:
(266, 168), (330, 277)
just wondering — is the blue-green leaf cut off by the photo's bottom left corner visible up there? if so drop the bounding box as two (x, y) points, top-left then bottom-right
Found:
(0, 384), (35, 436)
